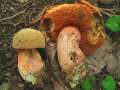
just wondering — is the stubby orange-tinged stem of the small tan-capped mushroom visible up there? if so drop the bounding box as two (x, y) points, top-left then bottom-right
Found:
(18, 49), (45, 85)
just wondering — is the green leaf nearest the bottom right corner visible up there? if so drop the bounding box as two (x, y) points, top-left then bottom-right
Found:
(102, 75), (116, 90)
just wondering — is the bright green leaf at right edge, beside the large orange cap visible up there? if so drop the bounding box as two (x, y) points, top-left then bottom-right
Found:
(105, 15), (120, 32)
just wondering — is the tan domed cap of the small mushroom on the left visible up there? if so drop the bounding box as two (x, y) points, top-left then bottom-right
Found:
(12, 28), (45, 49)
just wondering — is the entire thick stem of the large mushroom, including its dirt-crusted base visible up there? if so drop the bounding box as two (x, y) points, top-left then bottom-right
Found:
(57, 26), (86, 88)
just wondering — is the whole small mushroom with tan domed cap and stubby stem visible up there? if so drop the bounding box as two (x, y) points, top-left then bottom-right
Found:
(12, 28), (45, 85)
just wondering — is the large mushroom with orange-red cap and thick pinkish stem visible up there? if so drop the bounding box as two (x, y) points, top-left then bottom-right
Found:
(40, 0), (105, 88)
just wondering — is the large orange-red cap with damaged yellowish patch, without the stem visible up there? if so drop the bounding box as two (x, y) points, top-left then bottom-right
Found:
(41, 3), (105, 55)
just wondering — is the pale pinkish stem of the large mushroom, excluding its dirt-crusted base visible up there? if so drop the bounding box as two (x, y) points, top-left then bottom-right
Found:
(57, 27), (85, 73)
